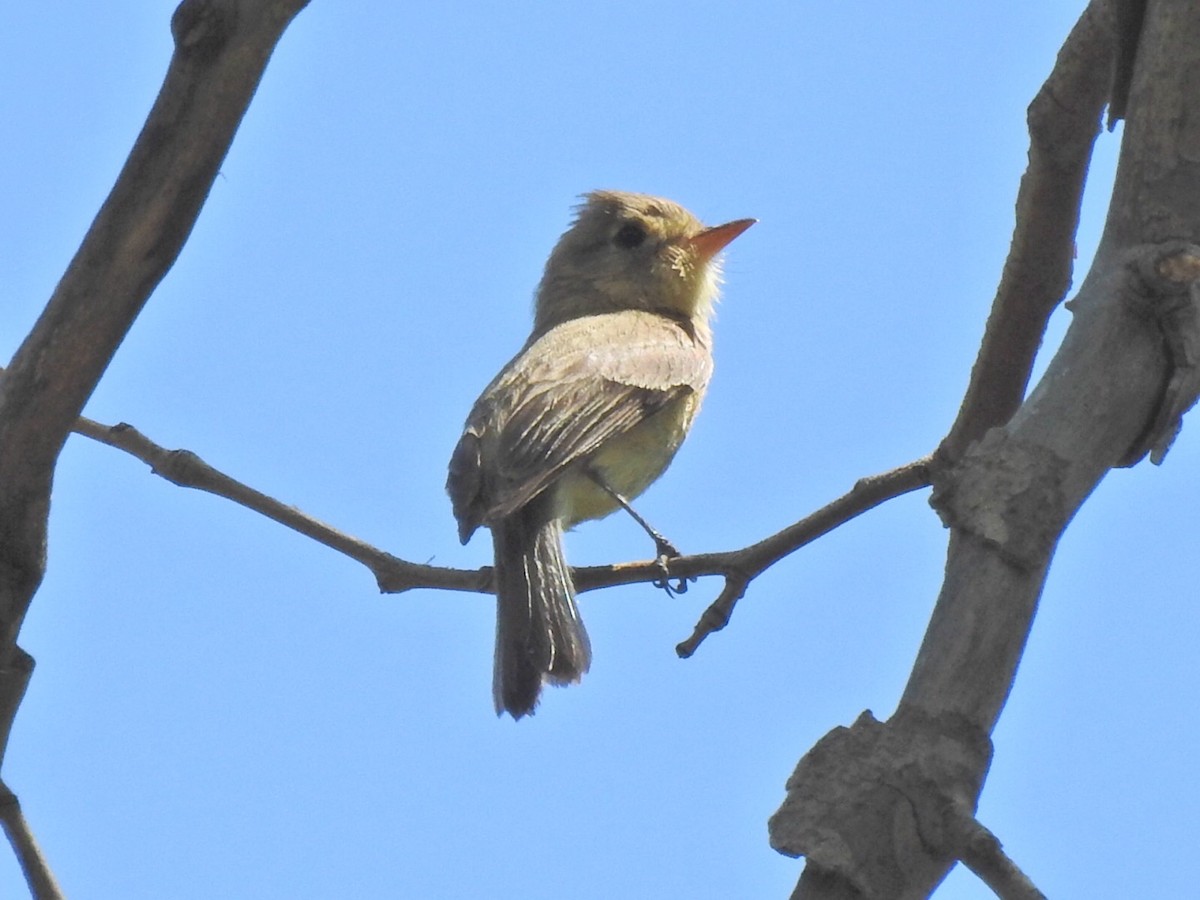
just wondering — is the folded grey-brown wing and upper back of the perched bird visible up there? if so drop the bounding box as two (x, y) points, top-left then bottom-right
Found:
(448, 312), (712, 536)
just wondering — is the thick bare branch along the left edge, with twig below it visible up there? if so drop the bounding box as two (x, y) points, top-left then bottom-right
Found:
(0, 0), (307, 896)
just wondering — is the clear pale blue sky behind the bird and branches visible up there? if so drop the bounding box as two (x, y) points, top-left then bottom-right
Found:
(0, 0), (1200, 900)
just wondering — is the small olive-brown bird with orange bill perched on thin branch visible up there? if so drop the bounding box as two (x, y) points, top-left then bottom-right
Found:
(446, 191), (755, 719)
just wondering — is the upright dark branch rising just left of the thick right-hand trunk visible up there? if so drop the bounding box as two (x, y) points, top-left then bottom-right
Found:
(936, 0), (1112, 462)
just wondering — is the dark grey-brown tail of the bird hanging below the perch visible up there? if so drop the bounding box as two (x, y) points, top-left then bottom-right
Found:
(492, 497), (592, 719)
